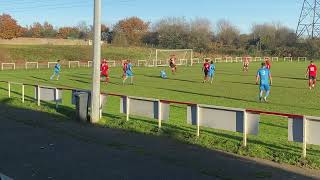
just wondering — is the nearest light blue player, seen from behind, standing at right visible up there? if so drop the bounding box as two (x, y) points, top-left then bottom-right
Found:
(256, 63), (272, 102)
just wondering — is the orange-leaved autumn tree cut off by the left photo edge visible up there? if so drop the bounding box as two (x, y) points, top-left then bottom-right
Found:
(0, 14), (23, 39)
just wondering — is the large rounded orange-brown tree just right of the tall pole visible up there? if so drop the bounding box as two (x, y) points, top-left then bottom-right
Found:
(113, 17), (150, 45)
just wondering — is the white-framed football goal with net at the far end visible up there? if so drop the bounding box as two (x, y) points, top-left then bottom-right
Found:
(153, 49), (193, 67)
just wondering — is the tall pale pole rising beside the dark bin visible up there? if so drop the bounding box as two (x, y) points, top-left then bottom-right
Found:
(90, 0), (101, 123)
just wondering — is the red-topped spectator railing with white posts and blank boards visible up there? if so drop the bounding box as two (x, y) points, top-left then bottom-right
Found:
(1, 81), (320, 157)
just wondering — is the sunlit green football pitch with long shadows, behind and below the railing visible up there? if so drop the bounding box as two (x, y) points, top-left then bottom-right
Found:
(0, 62), (320, 169)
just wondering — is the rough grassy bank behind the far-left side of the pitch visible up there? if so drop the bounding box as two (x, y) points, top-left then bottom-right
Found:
(0, 45), (155, 62)
